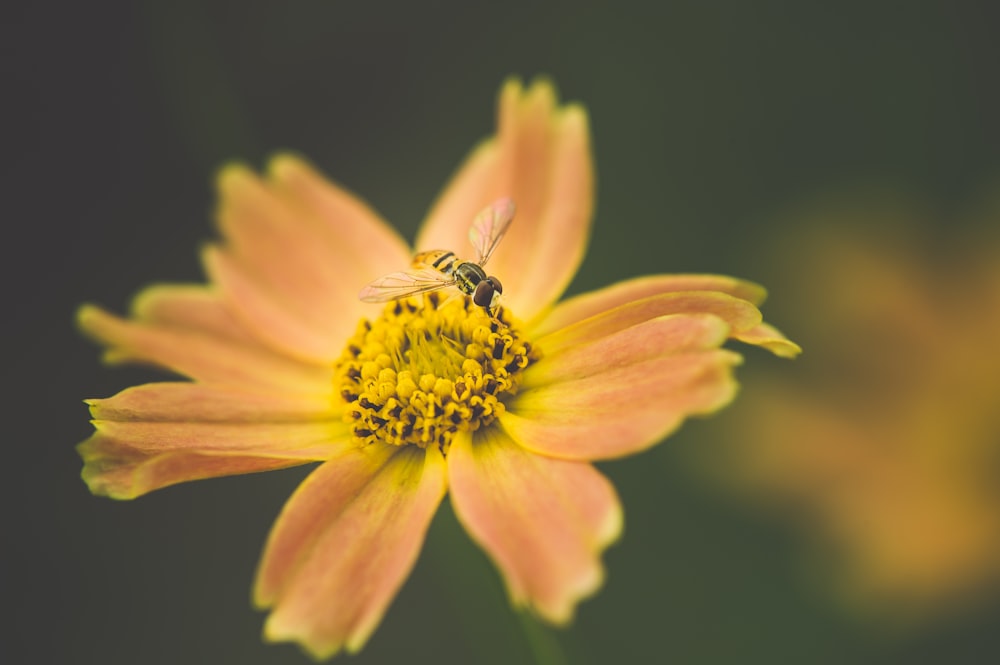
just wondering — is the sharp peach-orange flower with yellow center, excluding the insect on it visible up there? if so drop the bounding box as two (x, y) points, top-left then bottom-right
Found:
(79, 80), (798, 658)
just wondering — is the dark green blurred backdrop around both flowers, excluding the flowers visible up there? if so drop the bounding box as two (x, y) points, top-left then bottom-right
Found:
(7, 0), (1000, 665)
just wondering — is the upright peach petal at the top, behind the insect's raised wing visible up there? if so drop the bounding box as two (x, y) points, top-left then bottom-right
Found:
(417, 79), (594, 320)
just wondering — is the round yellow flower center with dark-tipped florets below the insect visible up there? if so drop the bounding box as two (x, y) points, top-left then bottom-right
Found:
(334, 292), (539, 453)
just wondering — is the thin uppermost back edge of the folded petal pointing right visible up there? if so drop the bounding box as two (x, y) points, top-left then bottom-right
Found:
(534, 275), (767, 336)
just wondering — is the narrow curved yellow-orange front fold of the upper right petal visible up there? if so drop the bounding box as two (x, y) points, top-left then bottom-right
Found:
(532, 291), (761, 354)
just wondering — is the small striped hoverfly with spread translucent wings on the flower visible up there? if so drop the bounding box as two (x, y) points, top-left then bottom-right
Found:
(358, 198), (514, 316)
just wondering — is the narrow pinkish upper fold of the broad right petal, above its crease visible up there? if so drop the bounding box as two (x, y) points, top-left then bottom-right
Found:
(520, 314), (729, 391)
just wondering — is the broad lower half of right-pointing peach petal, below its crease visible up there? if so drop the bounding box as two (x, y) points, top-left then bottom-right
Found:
(500, 349), (741, 460)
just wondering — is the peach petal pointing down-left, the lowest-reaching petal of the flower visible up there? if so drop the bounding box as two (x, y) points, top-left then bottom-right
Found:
(254, 444), (446, 658)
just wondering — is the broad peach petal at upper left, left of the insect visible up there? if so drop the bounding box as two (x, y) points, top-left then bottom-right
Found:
(205, 155), (410, 361)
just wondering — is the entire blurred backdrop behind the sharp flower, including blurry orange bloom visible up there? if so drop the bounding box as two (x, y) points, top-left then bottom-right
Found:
(7, 0), (1000, 665)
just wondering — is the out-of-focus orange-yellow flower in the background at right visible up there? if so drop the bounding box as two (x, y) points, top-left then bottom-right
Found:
(699, 206), (1000, 619)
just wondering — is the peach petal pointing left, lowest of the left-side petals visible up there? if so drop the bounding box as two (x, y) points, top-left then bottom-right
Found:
(78, 383), (351, 499)
